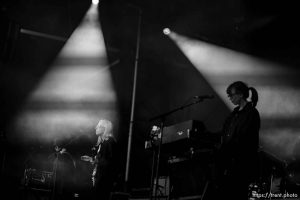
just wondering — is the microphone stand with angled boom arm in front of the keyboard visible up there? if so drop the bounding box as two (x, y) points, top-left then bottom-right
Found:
(149, 97), (209, 200)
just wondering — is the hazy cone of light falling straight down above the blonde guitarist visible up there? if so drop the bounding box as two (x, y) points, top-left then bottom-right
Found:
(11, 4), (118, 145)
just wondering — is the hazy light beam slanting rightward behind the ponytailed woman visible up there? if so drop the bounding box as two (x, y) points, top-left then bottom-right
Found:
(169, 32), (300, 162)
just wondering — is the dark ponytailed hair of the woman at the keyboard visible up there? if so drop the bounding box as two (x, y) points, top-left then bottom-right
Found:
(226, 81), (258, 107)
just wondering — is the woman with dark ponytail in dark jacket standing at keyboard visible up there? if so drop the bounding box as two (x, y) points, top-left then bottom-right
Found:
(218, 81), (260, 200)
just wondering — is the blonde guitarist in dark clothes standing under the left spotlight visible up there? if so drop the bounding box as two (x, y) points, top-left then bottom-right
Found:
(83, 119), (119, 200)
